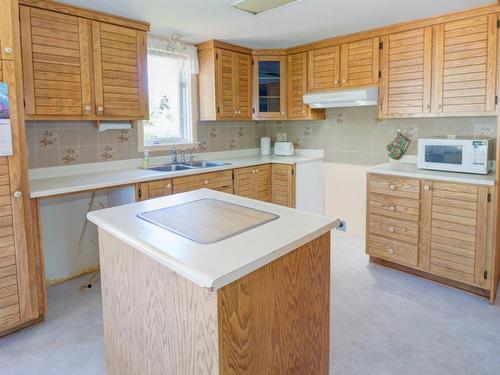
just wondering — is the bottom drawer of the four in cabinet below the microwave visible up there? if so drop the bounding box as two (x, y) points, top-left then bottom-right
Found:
(367, 235), (418, 267)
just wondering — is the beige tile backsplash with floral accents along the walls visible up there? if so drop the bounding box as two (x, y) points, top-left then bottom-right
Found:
(26, 107), (497, 168)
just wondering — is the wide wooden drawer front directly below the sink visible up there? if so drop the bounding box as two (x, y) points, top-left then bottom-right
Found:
(174, 170), (233, 194)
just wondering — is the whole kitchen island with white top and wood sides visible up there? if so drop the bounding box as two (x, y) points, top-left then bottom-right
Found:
(88, 189), (337, 375)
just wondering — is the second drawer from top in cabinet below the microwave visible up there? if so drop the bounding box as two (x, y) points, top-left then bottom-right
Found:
(369, 194), (420, 222)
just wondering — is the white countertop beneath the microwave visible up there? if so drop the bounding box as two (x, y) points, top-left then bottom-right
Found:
(368, 161), (495, 186)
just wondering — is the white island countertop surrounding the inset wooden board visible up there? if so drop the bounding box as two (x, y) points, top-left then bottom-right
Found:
(87, 189), (337, 289)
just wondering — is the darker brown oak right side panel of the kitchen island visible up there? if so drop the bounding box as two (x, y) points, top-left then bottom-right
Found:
(218, 233), (330, 375)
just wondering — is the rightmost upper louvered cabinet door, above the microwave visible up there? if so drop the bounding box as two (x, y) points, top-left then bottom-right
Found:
(432, 15), (498, 115)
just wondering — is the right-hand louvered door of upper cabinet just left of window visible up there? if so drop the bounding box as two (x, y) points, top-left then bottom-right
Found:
(92, 21), (149, 119)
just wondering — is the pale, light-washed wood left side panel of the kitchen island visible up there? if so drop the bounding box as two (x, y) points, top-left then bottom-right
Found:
(99, 229), (219, 375)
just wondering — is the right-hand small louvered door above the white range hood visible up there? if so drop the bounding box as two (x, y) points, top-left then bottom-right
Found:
(340, 38), (380, 88)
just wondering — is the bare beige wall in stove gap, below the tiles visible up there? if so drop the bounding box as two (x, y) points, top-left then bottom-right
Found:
(324, 163), (368, 238)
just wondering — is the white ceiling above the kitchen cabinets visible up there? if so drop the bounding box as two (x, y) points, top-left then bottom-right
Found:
(62, 0), (493, 48)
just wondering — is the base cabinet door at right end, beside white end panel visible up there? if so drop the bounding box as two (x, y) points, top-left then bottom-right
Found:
(271, 164), (295, 207)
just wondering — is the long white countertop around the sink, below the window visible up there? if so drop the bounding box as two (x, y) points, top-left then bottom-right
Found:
(30, 149), (323, 198)
